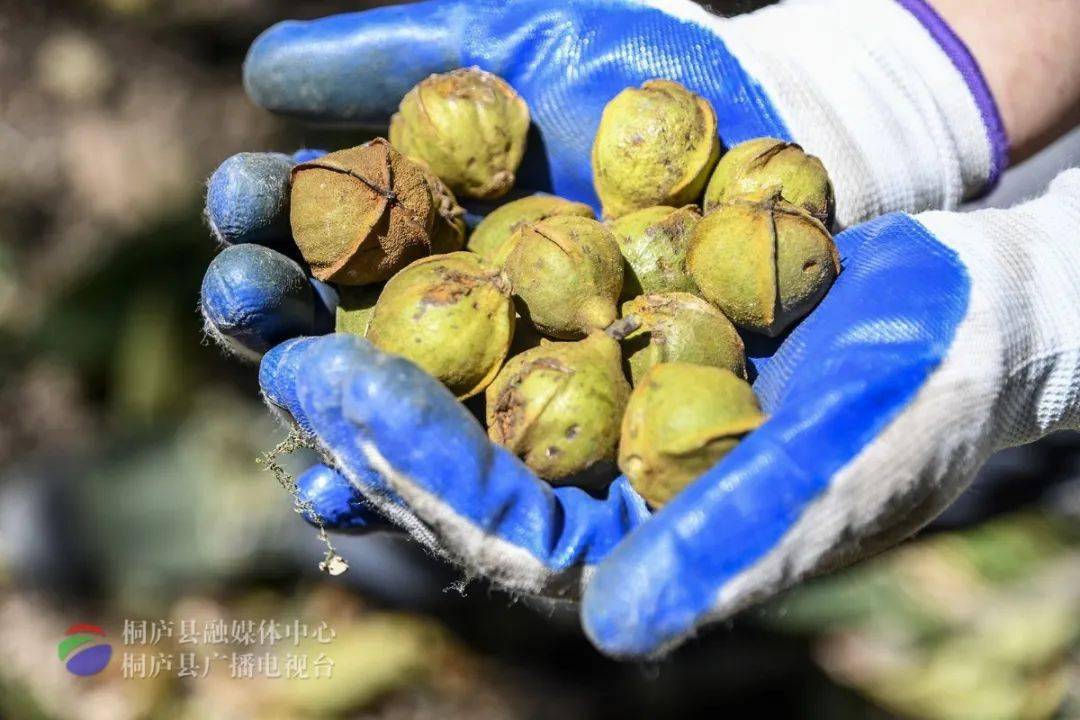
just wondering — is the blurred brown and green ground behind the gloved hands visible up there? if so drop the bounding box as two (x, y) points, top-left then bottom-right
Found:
(0, 0), (1080, 719)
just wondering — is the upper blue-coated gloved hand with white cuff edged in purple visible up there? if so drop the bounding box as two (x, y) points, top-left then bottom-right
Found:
(203, 0), (1008, 351)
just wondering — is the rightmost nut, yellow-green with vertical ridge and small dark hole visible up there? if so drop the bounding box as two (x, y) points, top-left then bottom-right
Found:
(687, 191), (840, 337)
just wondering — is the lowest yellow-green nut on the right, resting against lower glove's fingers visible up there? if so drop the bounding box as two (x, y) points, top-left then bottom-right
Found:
(619, 363), (765, 507)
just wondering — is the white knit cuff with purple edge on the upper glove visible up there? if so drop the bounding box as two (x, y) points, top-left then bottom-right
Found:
(654, 0), (1008, 226)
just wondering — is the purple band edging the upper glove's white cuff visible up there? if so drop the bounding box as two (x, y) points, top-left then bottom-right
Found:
(896, 0), (1009, 193)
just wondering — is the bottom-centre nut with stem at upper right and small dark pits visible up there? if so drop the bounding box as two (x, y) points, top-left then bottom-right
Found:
(486, 331), (630, 483)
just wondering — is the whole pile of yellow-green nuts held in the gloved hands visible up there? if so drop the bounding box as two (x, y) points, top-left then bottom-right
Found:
(291, 68), (840, 506)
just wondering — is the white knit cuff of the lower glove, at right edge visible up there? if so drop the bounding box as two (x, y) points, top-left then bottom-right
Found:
(916, 169), (1080, 452)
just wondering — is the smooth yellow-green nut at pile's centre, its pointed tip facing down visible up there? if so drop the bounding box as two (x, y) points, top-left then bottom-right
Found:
(499, 215), (622, 340)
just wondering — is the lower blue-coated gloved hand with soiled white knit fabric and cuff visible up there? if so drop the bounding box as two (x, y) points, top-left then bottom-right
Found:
(254, 171), (1080, 657)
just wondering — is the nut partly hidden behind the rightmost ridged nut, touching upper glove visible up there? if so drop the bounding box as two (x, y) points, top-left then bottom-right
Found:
(705, 137), (836, 228)
